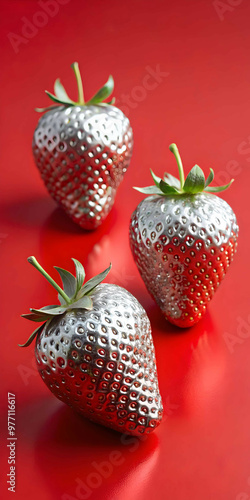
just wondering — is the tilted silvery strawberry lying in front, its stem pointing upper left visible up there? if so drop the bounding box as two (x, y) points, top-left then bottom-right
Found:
(21, 257), (162, 435)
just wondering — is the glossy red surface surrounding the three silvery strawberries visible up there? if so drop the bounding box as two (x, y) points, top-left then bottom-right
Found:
(0, 0), (250, 500)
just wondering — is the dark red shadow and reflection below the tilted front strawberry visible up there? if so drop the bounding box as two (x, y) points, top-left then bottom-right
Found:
(35, 405), (159, 500)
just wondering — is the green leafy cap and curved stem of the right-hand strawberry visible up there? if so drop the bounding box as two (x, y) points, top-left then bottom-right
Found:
(134, 144), (234, 196)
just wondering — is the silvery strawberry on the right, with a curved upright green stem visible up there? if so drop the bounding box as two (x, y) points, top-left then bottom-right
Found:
(130, 144), (238, 328)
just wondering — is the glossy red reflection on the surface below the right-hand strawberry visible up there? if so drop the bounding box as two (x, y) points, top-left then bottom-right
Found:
(147, 305), (226, 419)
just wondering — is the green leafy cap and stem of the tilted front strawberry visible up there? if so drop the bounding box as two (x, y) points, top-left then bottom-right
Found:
(19, 257), (111, 347)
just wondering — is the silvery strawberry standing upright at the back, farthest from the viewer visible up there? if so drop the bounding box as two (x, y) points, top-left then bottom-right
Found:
(32, 63), (133, 229)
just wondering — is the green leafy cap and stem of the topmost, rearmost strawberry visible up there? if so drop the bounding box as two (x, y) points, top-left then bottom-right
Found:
(35, 62), (115, 113)
